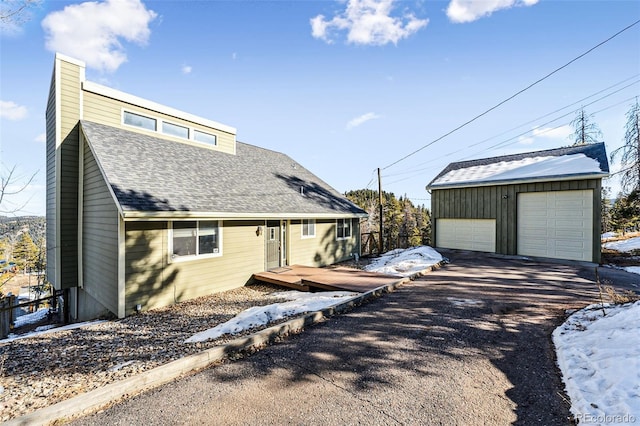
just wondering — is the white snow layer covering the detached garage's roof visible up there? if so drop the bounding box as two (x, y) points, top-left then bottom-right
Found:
(431, 154), (602, 187)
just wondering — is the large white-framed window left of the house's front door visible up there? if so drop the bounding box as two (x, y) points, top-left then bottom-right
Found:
(171, 220), (221, 259)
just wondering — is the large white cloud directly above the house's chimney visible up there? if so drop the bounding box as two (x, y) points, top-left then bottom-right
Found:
(42, 0), (157, 72)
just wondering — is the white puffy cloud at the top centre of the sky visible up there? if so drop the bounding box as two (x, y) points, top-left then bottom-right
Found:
(310, 0), (429, 46)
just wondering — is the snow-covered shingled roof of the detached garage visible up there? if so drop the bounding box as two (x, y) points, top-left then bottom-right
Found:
(427, 143), (609, 189)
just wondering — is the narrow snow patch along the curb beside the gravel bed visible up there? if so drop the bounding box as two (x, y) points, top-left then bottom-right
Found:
(185, 291), (360, 343)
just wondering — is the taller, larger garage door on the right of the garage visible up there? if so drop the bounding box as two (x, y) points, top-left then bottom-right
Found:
(518, 189), (593, 261)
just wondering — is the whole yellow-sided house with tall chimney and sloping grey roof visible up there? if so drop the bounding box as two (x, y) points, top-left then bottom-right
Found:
(46, 54), (366, 320)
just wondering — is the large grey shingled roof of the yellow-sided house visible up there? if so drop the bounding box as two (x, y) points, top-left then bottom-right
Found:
(81, 120), (366, 218)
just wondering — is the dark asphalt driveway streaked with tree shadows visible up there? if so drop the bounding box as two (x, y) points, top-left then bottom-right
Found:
(73, 252), (636, 425)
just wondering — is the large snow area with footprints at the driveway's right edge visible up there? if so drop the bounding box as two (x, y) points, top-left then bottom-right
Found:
(553, 301), (640, 424)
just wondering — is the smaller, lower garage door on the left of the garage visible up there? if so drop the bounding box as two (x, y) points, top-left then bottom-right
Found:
(436, 219), (496, 253)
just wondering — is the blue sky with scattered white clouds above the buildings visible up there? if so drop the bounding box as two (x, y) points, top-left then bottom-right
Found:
(0, 0), (640, 215)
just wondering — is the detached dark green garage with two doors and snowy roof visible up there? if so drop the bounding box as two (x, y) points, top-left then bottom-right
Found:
(427, 143), (609, 263)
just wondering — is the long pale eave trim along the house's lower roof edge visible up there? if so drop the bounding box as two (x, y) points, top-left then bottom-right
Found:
(122, 211), (368, 221)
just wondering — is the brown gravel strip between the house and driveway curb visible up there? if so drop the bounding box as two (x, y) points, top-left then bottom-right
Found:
(0, 285), (284, 422)
